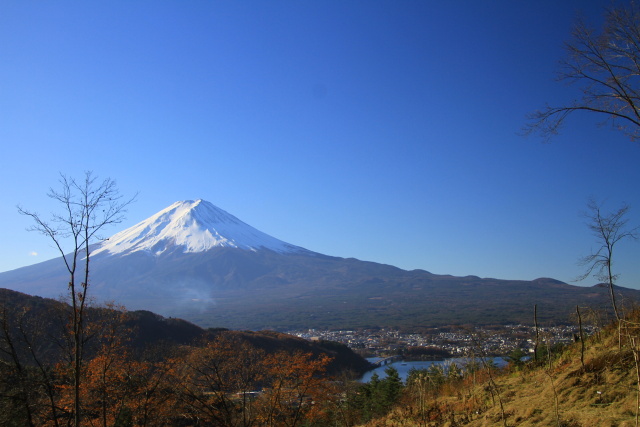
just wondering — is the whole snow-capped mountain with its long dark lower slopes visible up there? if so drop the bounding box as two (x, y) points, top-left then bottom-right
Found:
(0, 200), (640, 330)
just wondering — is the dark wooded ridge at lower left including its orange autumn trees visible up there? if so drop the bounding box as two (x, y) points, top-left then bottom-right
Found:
(0, 290), (369, 426)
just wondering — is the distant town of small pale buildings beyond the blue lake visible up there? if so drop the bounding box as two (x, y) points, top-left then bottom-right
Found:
(288, 325), (598, 357)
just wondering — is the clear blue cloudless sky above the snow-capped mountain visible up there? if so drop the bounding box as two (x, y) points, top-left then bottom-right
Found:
(0, 0), (640, 288)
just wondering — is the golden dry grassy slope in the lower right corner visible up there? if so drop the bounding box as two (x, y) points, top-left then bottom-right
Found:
(368, 318), (638, 427)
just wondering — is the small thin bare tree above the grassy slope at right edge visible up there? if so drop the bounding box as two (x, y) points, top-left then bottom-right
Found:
(578, 200), (639, 322)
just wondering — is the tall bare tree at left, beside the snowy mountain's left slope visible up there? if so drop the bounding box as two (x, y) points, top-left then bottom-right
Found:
(18, 172), (135, 427)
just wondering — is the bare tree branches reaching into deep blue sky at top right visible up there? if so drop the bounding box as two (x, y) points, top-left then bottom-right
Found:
(525, 3), (640, 140)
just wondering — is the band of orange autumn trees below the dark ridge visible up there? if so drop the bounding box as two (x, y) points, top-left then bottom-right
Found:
(51, 336), (334, 426)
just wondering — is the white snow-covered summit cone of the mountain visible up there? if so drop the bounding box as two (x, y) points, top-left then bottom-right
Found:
(93, 199), (306, 255)
